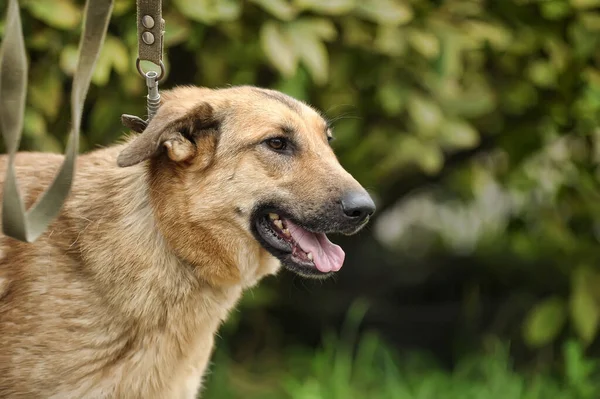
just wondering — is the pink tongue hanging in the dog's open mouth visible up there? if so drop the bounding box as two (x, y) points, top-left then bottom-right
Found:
(285, 220), (346, 273)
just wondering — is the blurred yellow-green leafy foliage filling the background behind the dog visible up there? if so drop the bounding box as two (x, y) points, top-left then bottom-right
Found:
(0, 0), (600, 378)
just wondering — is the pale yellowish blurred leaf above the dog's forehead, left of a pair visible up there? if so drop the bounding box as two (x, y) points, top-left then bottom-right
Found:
(260, 21), (298, 77)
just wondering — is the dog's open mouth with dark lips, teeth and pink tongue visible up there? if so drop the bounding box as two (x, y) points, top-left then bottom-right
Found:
(256, 212), (345, 275)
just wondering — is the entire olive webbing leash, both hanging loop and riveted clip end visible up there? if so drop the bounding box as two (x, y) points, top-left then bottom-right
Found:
(0, 0), (165, 242)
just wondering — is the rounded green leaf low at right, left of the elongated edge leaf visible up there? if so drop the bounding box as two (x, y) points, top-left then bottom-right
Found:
(523, 296), (567, 348)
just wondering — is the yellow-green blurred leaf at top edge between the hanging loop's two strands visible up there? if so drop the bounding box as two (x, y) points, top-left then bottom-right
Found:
(23, 0), (81, 30)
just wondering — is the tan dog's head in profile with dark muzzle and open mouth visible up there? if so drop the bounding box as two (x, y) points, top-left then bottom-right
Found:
(118, 87), (375, 277)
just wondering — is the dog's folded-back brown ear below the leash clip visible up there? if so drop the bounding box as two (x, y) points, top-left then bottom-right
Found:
(117, 102), (218, 168)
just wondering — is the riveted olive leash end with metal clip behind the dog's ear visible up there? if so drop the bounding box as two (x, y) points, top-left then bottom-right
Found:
(121, 0), (165, 133)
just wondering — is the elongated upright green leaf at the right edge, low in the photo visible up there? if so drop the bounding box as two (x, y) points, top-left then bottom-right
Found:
(570, 267), (600, 344)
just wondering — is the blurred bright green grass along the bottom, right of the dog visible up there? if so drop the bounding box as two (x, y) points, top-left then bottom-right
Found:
(202, 305), (600, 399)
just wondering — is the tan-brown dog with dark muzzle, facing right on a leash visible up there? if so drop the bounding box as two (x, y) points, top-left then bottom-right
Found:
(0, 87), (375, 399)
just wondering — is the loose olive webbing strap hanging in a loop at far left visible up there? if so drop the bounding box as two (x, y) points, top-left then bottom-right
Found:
(0, 0), (113, 242)
